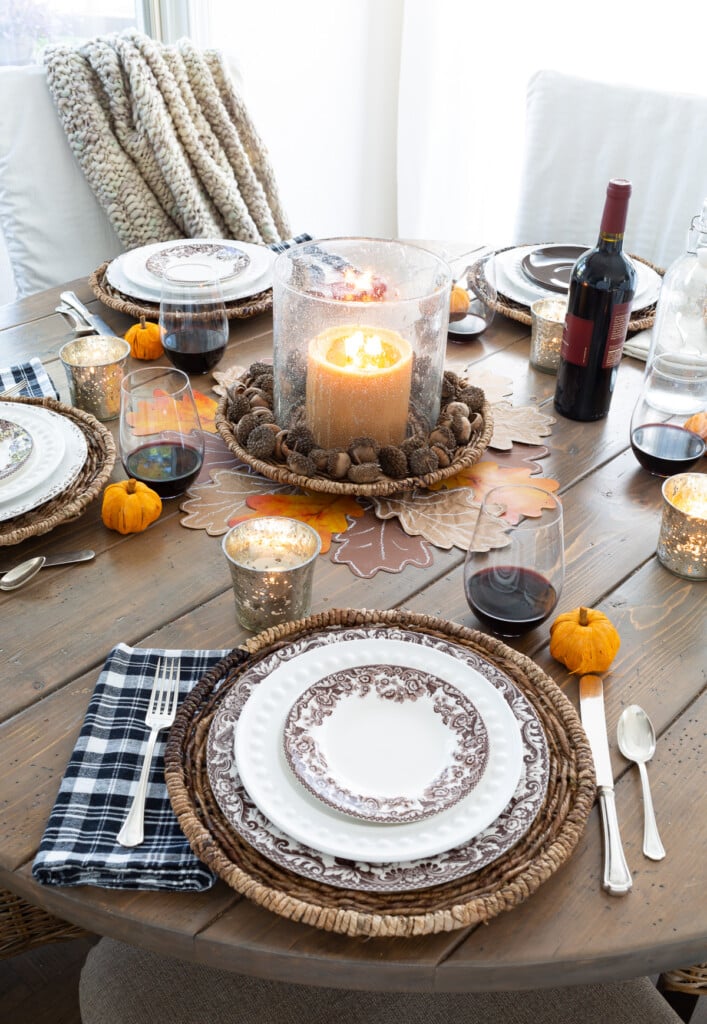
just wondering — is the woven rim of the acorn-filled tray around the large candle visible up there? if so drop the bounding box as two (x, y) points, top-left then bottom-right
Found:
(215, 395), (494, 498)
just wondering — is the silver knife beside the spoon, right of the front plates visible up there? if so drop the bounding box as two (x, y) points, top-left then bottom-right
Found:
(579, 676), (633, 896)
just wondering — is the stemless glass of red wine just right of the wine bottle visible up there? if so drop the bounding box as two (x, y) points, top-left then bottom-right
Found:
(631, 352), (707, 476)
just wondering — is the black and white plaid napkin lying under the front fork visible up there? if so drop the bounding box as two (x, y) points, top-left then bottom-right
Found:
(32, 644), (228, 890)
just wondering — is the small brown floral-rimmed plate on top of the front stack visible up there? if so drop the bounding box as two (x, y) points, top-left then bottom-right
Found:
(283, 665), (489, 824)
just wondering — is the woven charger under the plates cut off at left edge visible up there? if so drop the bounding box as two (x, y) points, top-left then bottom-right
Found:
(0, 398), (116, 546)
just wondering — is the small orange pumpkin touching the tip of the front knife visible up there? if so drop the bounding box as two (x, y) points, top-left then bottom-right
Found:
(550, 608), (621, 676)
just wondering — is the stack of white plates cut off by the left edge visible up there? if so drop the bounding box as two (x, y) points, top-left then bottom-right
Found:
(0, 402), (88, 522)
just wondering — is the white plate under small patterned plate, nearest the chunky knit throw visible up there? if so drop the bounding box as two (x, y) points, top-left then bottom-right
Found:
(106, 239), (278, 302)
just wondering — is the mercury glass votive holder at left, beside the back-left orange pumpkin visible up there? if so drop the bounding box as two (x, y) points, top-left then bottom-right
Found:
(59, 334), (130, 421)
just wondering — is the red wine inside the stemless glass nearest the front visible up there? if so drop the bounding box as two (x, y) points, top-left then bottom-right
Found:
(464, 565), (558, 636)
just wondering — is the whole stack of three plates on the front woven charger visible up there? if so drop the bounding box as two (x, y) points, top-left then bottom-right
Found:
(207, 627), (549, 892)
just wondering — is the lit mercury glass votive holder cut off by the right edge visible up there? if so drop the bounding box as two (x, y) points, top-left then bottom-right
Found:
(657, 473), (707, 580)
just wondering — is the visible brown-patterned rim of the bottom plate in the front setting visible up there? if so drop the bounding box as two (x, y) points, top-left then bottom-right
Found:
(206, 626), (549, 892)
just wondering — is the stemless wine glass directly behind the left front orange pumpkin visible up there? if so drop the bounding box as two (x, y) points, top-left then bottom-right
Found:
(120, 367), (204, 498)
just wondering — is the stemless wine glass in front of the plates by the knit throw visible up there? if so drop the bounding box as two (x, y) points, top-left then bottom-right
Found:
(160, 262), (228, 374)
